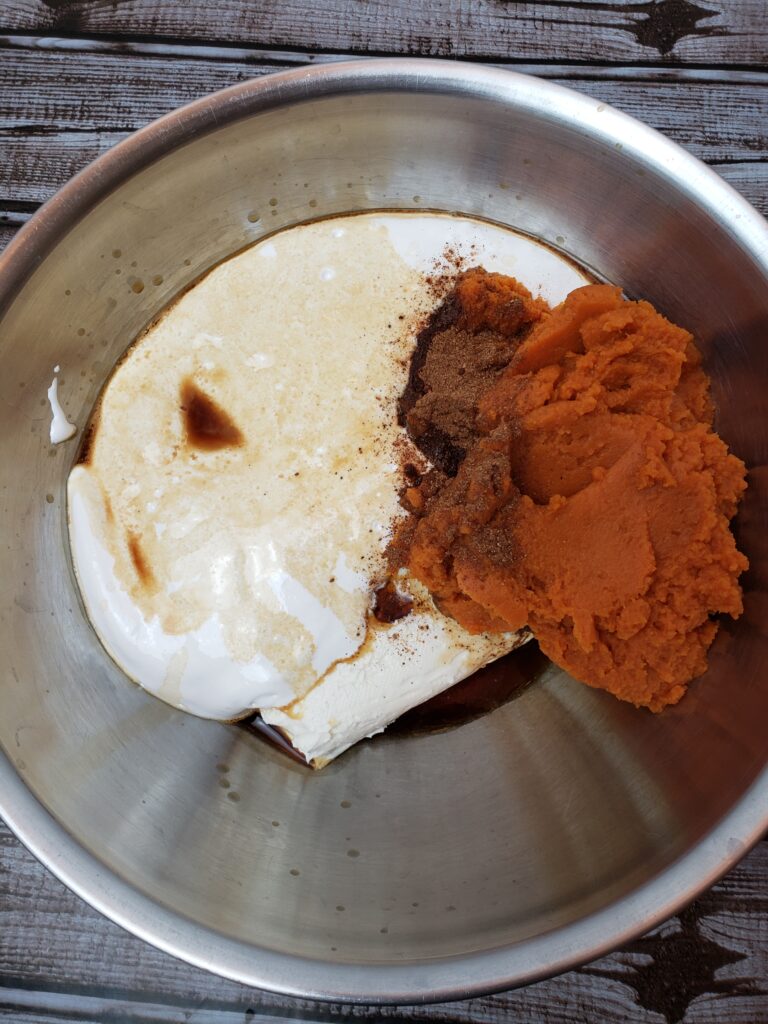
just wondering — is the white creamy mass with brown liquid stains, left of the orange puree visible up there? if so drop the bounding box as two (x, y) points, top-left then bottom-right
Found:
(69, 213), (586, 764)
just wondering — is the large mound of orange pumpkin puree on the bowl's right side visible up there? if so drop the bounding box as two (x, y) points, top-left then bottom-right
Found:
(409, 285), (748, 711)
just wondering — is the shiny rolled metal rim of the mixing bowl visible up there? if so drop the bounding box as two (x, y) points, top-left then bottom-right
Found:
(0, 58), (768, 1005)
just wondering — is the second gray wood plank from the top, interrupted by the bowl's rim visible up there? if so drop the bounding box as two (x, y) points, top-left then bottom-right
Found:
(0, 46), (768, 161)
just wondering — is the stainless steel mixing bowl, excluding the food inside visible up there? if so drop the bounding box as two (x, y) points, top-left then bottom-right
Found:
(0, 60), (768, 1002)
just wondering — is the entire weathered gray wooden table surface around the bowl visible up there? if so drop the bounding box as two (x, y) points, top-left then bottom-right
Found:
(0, 0), (768, 1024)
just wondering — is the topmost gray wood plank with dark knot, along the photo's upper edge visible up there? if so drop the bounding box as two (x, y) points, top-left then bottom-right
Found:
(0, 0), (768, 65)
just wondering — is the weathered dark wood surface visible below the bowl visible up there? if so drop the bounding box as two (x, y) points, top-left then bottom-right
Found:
(0, 822), (768, 1024)
